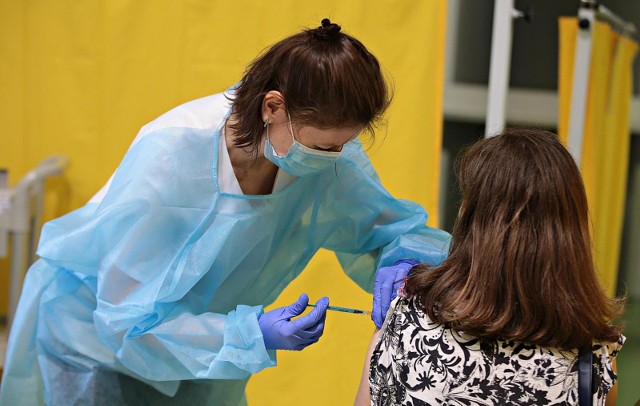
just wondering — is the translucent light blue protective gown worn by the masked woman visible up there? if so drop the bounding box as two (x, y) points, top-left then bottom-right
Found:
(0, 90), (449, 405)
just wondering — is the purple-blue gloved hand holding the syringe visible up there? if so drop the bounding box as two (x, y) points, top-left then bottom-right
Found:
(258, 293), (329, 351)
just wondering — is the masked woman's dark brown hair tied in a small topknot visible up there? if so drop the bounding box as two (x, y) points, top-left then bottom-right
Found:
(231, 19), (391, 149)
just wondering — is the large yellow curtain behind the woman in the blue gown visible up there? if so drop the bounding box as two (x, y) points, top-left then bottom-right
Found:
(0, 0), (446, 405)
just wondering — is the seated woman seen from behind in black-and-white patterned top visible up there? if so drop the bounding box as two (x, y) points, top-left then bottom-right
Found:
(356, 129), (625, 405)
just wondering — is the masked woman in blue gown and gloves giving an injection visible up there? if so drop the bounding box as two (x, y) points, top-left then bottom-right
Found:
(0, 19), (449, 406)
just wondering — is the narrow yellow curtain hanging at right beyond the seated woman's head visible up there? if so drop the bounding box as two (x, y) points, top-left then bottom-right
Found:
(558, 17), (638, 295)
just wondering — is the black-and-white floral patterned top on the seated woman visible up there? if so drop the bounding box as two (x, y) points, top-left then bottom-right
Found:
(369, 297), (625, 406)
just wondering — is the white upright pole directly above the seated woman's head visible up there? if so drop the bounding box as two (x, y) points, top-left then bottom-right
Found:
(485, 0), (515, 137)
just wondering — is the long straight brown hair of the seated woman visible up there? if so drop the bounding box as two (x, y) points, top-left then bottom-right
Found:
(405, 129), (622, 349)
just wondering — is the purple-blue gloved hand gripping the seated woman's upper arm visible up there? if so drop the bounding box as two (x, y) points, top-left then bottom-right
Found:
(371, 259), (418, 328)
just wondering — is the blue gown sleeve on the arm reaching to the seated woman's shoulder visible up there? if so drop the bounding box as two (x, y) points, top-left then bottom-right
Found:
(324, 142), (451, 292)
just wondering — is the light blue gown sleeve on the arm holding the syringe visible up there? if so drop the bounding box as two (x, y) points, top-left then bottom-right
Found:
(36, 129), (275, 381)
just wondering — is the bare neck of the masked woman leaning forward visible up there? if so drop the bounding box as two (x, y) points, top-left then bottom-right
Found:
(224, 118), (278, 195)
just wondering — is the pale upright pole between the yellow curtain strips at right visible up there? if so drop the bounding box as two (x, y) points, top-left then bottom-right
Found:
(567, 8), (595, 166)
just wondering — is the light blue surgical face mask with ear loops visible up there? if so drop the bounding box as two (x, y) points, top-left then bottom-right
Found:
(264, 111), (340, 178)
